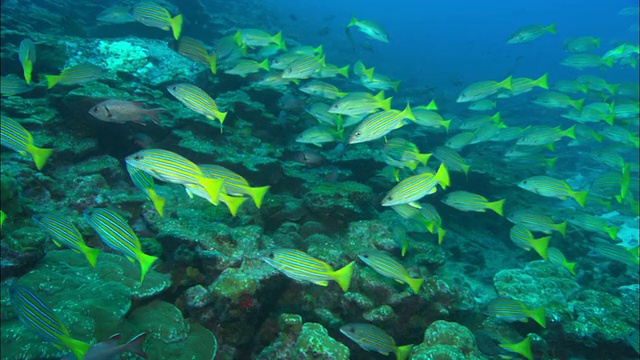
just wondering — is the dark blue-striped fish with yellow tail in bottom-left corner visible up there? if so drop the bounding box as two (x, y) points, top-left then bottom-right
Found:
(9, 283), (91, 360)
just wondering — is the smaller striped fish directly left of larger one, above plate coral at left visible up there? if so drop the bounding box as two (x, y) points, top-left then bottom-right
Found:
(31, 214), (100, 267)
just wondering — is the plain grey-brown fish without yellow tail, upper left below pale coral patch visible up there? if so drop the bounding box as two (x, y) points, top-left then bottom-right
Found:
(89, 99), (165, 125)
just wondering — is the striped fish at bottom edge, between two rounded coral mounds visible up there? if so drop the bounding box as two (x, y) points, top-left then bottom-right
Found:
(340, 323), (413, 360)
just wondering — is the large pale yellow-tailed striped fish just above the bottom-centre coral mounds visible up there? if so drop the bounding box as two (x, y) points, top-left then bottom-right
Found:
(261, 249), (354, 292)
